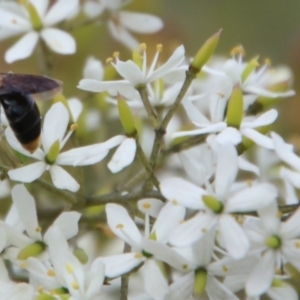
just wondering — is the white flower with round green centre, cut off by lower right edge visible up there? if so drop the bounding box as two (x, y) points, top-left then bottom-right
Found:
(245, 203), (300, 296)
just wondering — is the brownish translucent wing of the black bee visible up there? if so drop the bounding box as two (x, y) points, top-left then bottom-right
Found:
(0, 73), (62, 100)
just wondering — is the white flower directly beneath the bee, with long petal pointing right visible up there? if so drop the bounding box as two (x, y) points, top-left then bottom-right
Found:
(5, 102), (125, 192)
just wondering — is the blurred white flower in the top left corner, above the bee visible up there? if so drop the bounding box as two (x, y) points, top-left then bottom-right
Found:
(0, 0), (79, 63)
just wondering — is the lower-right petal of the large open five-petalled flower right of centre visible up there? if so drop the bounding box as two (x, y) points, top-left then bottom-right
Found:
(219, 215), (250, 259)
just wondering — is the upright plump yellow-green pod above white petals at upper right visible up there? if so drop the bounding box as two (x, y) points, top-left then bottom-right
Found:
(227, 86), (244, 128)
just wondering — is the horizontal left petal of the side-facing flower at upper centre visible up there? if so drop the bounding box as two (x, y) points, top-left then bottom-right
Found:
(77, 79), (130, 93)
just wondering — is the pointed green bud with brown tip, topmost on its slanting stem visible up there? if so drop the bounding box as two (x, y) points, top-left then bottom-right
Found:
(189, 30), (222, 74)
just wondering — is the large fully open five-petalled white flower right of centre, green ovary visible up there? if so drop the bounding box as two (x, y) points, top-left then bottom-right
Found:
(161, 143), (277, 259)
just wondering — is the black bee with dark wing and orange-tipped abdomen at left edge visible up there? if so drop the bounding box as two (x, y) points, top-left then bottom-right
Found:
(0, 72), (62, 153)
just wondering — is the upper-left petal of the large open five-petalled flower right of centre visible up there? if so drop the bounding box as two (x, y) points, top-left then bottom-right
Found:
(160, 178), (206, 209)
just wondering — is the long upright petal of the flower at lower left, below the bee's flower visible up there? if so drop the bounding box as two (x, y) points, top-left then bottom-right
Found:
(11, 184), (42, 240)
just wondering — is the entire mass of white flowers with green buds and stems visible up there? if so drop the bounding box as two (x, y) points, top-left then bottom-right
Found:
(0, 0), (300, 300)
